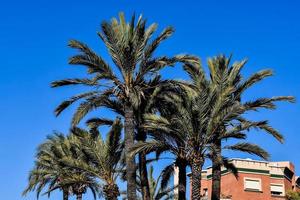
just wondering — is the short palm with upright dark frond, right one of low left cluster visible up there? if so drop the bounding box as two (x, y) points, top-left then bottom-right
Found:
(62, 118), (124, 200)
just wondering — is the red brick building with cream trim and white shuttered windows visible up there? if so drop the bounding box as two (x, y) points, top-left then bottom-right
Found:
(191, 159), (300, 200)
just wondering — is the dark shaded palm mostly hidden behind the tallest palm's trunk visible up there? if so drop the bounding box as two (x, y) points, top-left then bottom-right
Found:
(86, 75), (177, 200)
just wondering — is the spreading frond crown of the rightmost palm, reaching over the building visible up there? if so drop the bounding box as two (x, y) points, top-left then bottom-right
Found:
(208, 55), (295, 142)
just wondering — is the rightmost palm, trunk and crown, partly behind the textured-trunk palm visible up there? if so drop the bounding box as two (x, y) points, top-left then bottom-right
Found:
(185, 60), (294, 198)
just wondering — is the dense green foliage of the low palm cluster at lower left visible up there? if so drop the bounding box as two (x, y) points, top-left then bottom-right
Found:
(23, 118), (124, 199)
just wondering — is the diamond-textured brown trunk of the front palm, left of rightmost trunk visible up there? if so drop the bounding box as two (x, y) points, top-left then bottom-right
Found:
(192, 156), (204, 200)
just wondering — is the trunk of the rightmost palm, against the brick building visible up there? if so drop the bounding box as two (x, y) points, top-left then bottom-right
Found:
(211, 140), (222, 200)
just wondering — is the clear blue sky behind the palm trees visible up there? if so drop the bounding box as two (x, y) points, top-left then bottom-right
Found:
(0, 0), (300, 200)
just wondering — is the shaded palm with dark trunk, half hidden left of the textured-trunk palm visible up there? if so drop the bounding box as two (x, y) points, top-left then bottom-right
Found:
(132, 85), (204, 200)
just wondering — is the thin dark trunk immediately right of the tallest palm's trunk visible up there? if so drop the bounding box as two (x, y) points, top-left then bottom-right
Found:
(137, 130), (150, 200)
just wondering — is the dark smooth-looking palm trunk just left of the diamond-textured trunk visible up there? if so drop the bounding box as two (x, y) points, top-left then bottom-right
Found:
(176, 160), (187, 200)
